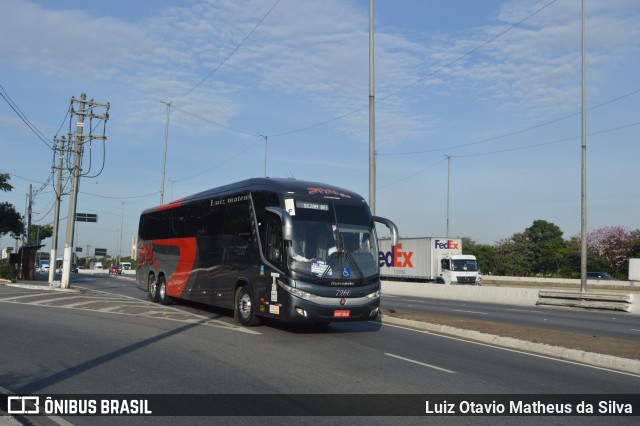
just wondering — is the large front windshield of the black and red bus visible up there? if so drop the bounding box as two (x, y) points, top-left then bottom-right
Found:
(287, 200), (379, 282)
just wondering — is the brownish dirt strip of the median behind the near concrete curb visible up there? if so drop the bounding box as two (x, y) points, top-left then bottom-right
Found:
(381, 308), (640, 360)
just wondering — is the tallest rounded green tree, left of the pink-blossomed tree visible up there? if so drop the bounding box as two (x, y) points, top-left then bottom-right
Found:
(524, 219), (564, 274)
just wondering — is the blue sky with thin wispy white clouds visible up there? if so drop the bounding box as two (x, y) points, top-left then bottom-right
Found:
(0, 0), (640, 256)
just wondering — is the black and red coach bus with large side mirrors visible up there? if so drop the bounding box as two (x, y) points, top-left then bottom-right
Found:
(136, 178), (397, 325)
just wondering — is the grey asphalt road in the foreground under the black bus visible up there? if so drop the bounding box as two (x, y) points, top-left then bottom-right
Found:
(0, 276), (640, 424)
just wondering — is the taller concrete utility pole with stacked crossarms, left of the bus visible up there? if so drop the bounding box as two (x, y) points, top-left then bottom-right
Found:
(60, 93), (109, 288)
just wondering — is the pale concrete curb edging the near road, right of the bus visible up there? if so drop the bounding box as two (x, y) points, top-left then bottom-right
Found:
(381, 315), (640, 375)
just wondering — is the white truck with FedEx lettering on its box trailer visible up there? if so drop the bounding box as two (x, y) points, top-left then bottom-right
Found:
(378, 237), (480, 284)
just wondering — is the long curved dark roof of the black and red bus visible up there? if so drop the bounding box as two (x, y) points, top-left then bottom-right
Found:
(143, 178), (366, 214)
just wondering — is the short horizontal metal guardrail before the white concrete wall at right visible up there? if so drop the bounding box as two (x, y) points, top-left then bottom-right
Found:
(536, 290), (633, 312)
